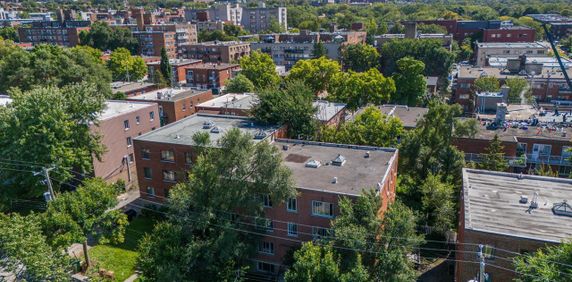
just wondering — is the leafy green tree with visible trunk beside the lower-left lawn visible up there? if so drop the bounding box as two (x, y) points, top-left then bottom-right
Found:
(42, 178), (128, 267)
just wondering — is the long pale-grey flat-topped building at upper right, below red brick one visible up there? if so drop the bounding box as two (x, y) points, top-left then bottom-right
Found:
(475, 42), (550, 67)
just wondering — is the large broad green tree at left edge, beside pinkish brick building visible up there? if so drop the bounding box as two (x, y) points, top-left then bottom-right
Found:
(0, 85), (105, 198)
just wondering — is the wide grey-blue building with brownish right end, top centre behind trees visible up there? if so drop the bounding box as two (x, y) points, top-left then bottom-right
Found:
(250, 31), (367, 70)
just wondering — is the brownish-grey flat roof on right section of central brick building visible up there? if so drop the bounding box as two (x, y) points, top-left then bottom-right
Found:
(274, 139), (397, 196)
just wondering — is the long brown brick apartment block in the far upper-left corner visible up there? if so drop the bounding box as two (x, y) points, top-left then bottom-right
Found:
(18, 21), (91, 47)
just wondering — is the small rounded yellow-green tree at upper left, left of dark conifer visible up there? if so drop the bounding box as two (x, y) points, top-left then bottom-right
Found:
(107, 48), (147, 81)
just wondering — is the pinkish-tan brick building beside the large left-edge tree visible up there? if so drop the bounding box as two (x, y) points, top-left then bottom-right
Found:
(91, 101), (160, 185)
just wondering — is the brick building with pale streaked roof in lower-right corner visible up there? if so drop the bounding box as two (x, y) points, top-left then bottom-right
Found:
(455, 169), (572, 281)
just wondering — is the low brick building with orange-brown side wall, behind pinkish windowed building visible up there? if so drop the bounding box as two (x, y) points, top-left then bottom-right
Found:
(127, 88), (213, 126)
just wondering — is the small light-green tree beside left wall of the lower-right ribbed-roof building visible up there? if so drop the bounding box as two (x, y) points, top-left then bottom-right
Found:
(420, 173), (456, 233)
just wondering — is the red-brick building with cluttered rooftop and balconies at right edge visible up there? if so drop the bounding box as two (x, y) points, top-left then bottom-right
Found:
(453, 104), (572, 177)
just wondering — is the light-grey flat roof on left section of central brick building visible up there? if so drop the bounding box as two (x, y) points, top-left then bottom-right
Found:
(135, 113), (279, 146)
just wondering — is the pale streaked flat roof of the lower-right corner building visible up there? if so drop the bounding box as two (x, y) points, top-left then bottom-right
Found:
(463, 168), (572, 243)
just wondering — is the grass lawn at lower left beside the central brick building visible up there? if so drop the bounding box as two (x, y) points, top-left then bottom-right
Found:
(89, 217), (154, 282)
